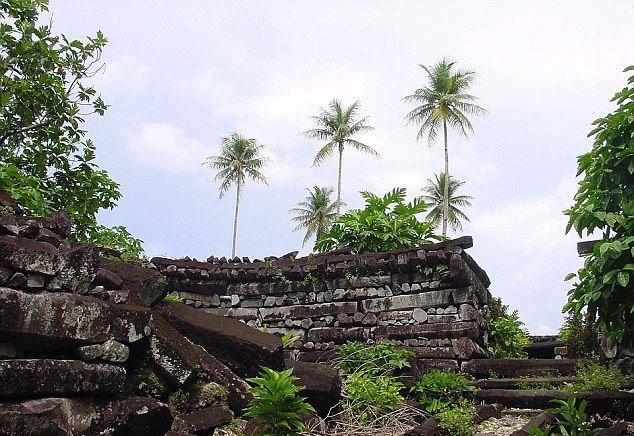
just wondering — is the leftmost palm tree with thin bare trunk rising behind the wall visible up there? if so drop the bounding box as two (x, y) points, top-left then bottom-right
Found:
(203, 133), (268, 257)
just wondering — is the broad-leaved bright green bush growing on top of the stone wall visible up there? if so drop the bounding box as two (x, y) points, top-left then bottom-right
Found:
(315, 188), (440, 253)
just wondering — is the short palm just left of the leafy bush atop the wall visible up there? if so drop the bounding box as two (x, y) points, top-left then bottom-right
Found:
(290, 185), (337, 246)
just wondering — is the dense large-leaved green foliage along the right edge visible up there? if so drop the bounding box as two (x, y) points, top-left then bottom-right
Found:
(564, 65), (634, 345)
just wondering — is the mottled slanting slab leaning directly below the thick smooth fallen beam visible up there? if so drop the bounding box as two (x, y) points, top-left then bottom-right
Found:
(150, 316), (252, 413)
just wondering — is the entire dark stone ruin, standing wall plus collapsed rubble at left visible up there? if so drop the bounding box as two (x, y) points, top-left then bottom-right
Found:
(0, 190), (489, 435)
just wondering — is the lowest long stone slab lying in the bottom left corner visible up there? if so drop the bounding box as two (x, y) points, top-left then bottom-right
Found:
(0, 397), (172, 436)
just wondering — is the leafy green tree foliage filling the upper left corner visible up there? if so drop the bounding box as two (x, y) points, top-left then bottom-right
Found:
(0, 0), (141, 255)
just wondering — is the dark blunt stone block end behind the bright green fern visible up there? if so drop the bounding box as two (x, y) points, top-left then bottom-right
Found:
(284, 359), (341, 416)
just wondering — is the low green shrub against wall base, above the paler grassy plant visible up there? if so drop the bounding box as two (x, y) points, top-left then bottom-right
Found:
(337, 341), (414, 375)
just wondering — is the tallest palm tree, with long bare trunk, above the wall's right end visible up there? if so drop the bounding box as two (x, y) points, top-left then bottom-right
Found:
(404, 59), (486, 236)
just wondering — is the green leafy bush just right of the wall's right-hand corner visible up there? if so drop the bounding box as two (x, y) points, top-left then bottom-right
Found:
(488, 310), (531, 359)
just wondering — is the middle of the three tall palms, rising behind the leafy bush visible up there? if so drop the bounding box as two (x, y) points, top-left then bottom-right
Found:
(304, 99), (379, 216)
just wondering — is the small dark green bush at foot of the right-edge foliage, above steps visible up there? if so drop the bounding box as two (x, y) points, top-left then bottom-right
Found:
(559, 312), (601, 359)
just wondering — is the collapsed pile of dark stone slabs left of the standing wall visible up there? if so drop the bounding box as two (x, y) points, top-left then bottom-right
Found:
(0, 190), (340, 435)
